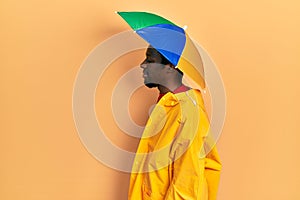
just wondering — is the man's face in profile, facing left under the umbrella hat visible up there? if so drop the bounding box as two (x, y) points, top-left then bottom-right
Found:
(141, 46), (166, 88)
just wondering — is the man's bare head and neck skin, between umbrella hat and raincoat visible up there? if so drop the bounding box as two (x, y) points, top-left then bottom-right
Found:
(141, 46), (182, 93)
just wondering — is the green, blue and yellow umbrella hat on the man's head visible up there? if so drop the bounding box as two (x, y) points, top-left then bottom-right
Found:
(117, 12), (205, 88)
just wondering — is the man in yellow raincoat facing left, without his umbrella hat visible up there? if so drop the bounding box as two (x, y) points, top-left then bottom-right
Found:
(128, 46), (221, 200)
